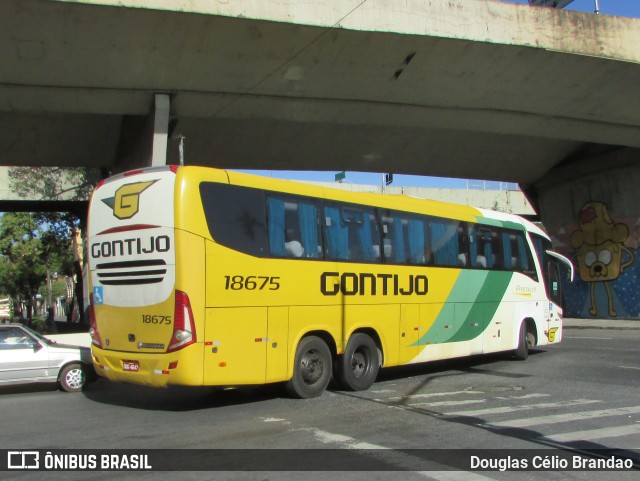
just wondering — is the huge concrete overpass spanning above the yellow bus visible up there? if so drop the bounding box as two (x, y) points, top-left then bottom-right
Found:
(0, 0), (640, 316)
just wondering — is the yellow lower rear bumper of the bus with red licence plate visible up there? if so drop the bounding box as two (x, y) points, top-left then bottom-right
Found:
(91, 345), (202, 387)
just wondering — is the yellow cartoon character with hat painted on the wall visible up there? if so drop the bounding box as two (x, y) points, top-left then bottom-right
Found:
(571, 202), (634, 317)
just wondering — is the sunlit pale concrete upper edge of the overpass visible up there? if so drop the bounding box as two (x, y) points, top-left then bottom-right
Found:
(55, 0), (640, 62)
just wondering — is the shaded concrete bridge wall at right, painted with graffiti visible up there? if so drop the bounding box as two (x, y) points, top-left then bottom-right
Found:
(534, 148), (640, 319)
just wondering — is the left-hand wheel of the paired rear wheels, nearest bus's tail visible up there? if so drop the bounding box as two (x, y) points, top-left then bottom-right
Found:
(287, 336), (331, 399)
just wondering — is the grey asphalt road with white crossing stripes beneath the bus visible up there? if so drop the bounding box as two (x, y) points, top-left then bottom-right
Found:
(0, 329), (640, 480)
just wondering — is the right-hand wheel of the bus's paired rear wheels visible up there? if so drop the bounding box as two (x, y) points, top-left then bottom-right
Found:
(336, 333), (380, 391)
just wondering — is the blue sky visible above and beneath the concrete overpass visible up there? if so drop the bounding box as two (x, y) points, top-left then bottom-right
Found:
(241, 0), (640, 189)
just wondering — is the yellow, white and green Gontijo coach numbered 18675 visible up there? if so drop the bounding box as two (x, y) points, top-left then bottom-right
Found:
(88, 166), (573, 398)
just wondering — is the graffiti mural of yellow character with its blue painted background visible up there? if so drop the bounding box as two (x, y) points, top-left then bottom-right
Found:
(565, 201), (640, 317)
